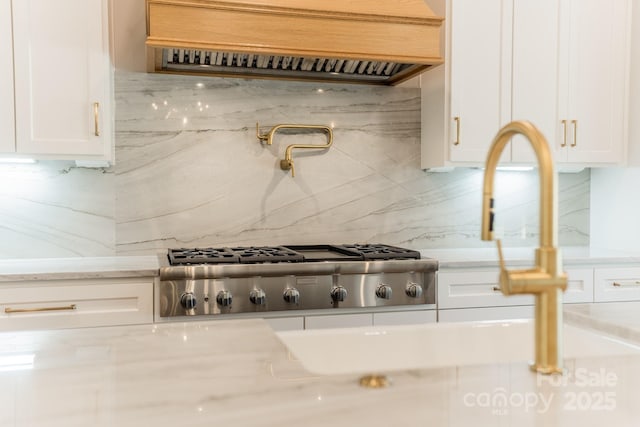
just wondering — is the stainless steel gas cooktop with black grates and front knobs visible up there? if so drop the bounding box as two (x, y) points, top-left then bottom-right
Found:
(158, 244), (438, 317)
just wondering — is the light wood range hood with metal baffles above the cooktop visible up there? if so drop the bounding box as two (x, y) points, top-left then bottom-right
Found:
(146, 0), (443, 84)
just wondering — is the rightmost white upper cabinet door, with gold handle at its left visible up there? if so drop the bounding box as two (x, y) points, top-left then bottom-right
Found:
(558, 0), (630, 164)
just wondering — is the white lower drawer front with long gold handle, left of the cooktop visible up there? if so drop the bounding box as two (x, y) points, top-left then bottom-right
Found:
(0, 278), (154, 331)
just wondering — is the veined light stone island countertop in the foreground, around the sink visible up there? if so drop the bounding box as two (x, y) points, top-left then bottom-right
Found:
(0, 320), (640, 427)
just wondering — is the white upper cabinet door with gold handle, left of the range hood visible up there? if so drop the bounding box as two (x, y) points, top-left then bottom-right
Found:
(13, 0), (110, 159)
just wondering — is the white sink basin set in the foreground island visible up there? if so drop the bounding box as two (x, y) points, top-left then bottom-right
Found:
(277, 320), (640, 375)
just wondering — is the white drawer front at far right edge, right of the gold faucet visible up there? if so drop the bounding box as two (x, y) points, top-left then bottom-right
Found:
(594, 267), (640, 302)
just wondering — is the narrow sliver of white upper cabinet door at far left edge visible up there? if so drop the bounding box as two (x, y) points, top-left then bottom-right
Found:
(0, 0), (16, 153)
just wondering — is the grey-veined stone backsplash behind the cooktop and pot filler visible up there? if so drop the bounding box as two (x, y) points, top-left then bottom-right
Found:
(0, 72), (590, 258)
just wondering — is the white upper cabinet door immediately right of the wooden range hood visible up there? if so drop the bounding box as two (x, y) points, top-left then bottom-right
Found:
(449, 0), (511, 163)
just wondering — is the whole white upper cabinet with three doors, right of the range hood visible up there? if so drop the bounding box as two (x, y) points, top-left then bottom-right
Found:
(421, 0), (630, 168)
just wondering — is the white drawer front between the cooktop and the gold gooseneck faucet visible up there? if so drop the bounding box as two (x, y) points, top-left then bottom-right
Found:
(437, 269), (534, 309)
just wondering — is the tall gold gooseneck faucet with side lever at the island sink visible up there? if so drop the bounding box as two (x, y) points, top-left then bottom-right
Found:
(482, 121), (567, 374)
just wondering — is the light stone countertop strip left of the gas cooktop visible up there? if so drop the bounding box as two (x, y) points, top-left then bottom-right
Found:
(0, 256), (160, 282)
